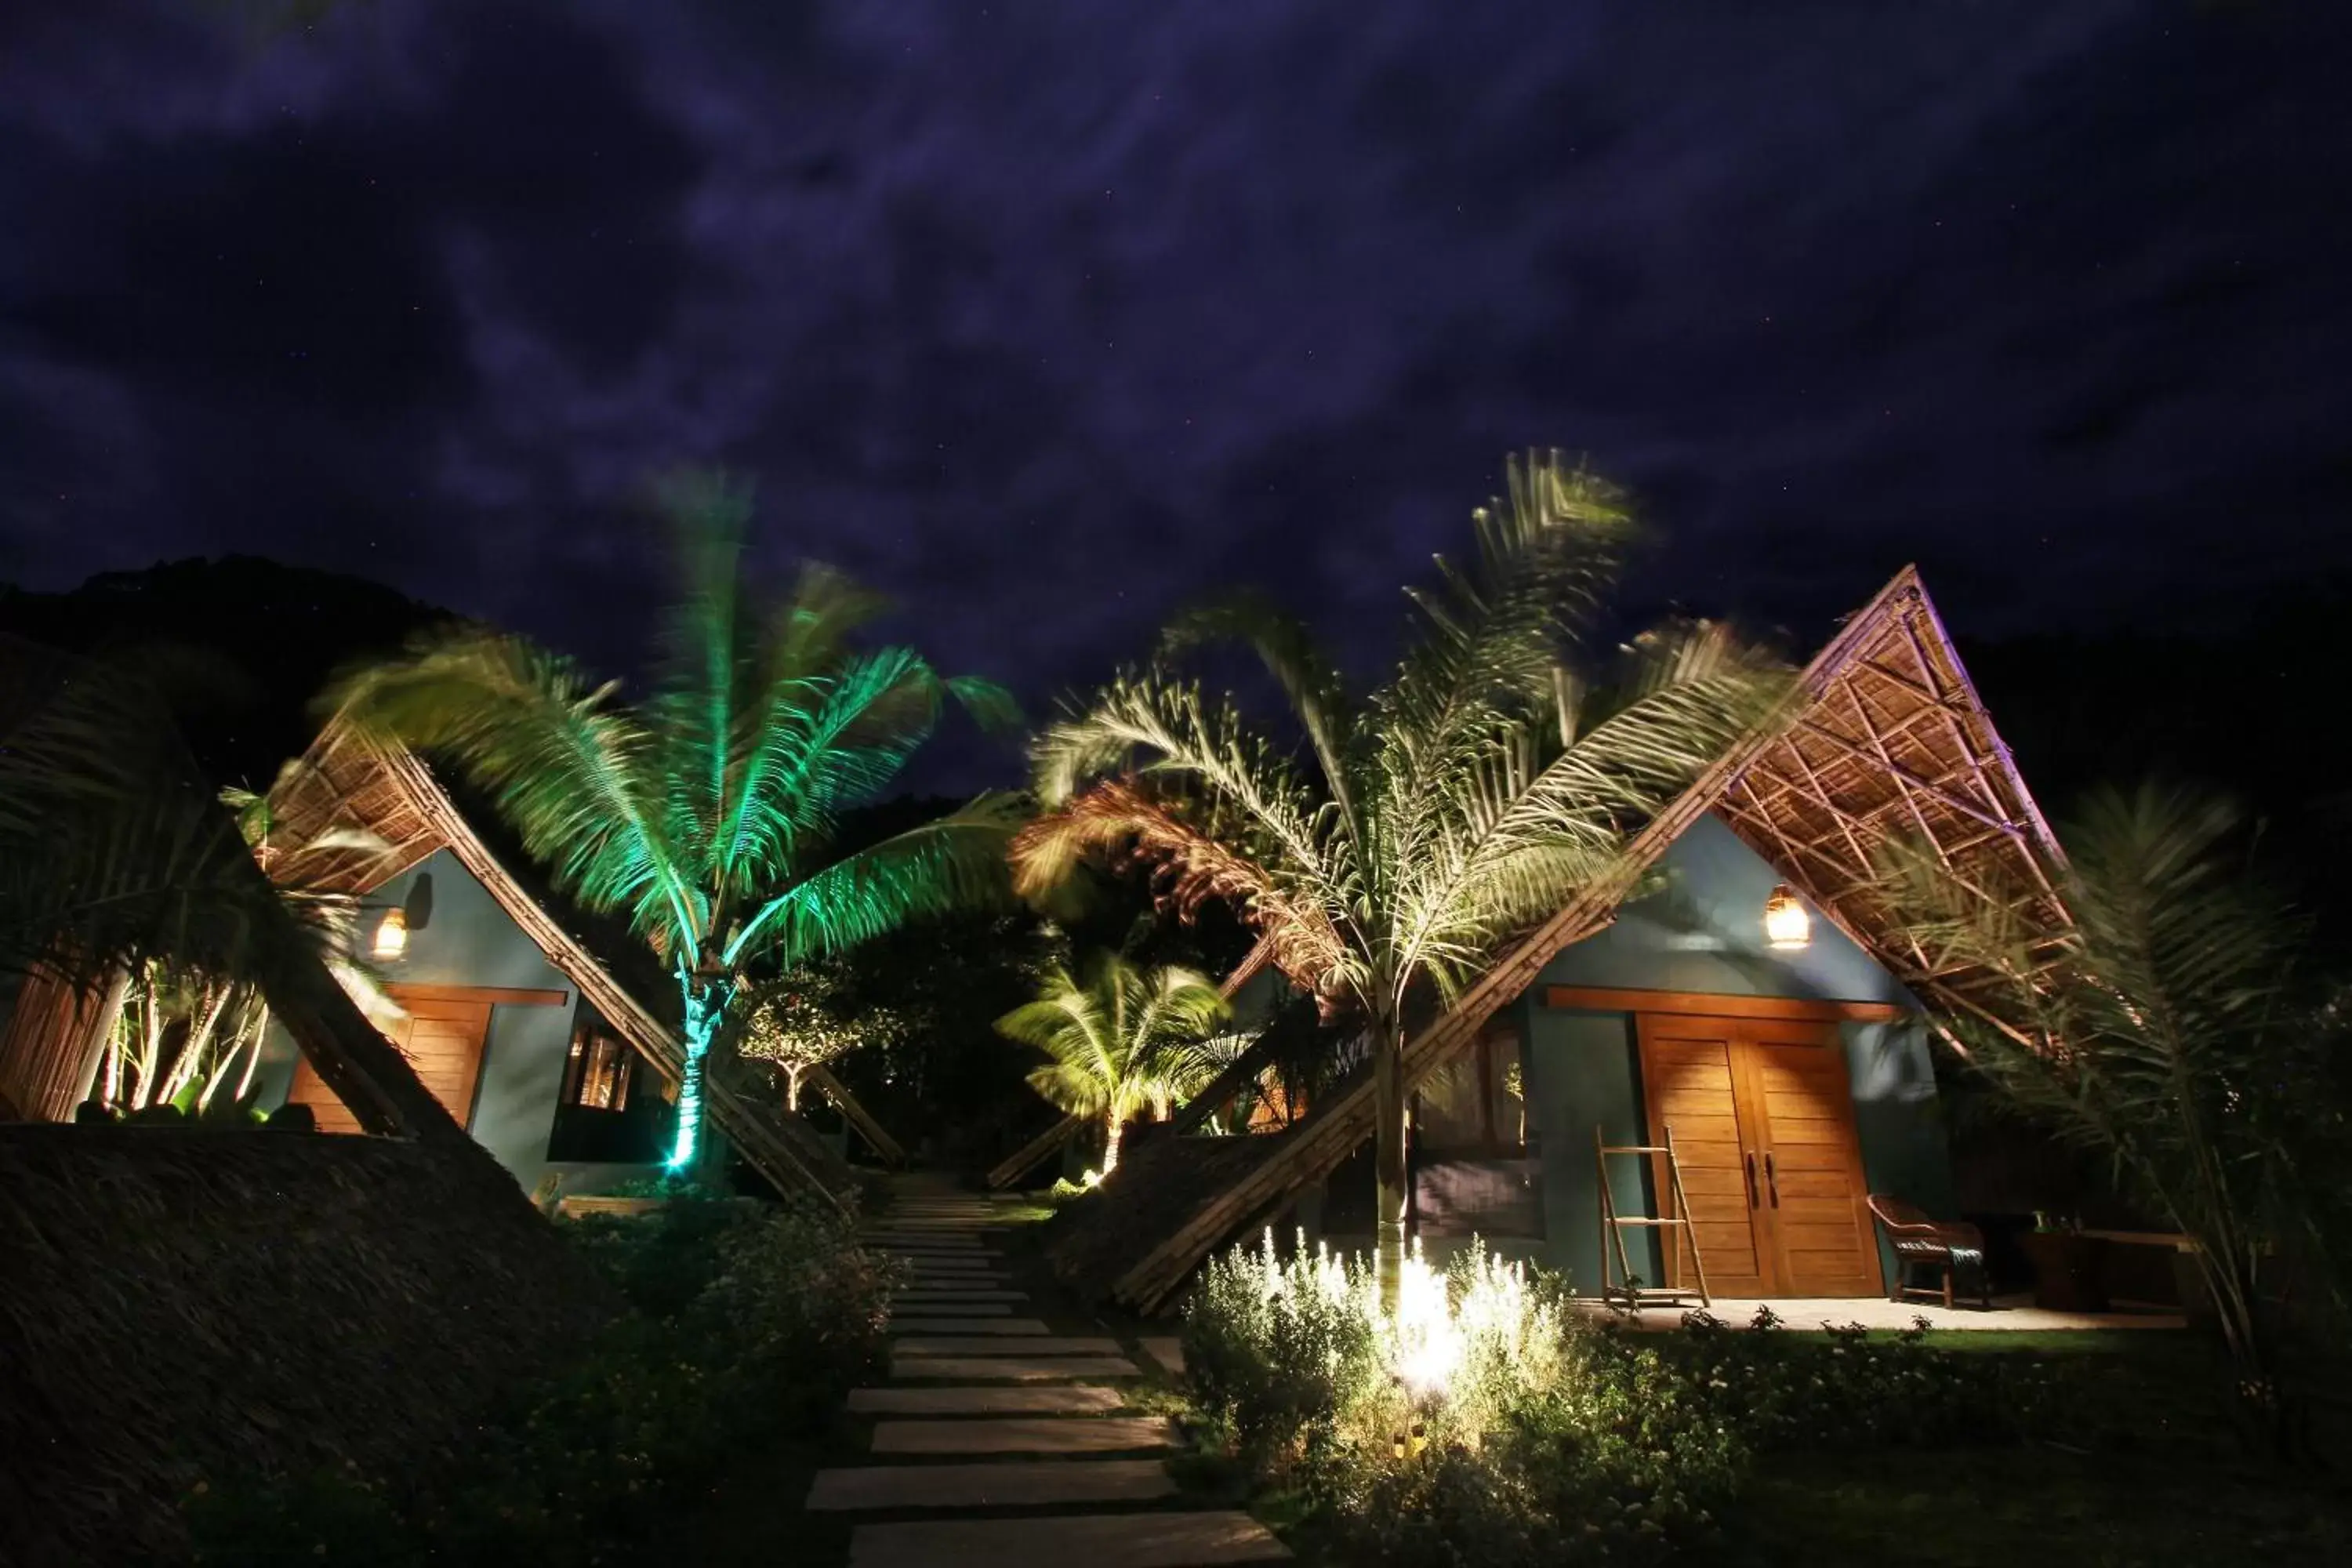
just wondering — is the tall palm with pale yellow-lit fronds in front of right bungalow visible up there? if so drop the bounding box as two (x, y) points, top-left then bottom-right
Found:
(1016, 454), (1780, 1300)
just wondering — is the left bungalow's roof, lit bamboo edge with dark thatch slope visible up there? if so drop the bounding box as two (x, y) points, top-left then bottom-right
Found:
(263, 720), (863, 1201)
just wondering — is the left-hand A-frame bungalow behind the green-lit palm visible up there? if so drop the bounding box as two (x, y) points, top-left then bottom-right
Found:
(236, 720), (903, 1201)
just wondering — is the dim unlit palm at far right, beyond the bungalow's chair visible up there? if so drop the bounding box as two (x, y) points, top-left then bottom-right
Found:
(1889, 787), (2343, 1441)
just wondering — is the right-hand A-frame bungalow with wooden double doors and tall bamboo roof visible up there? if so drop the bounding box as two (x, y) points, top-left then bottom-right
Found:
(1063, 569), (2065, 1312)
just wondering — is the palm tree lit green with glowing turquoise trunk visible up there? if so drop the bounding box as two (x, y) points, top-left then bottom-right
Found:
(332, 475), (1016, 1171)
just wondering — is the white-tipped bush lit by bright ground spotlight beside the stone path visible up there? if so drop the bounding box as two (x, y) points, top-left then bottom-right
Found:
(1185, 1236), (1743, 1566)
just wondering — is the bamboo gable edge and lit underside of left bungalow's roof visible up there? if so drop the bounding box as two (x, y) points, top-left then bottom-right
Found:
(256, 715), (884, 1213)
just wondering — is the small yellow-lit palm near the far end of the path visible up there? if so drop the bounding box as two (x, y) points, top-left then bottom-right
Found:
(997, 952), (1225, 1175)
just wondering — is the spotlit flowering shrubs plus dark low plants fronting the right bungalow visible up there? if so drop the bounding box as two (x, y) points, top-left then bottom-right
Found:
(1183, 1236), (2065, 1568)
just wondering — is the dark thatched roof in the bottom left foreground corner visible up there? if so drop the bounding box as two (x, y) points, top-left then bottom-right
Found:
(0, 1126), (609, 1566)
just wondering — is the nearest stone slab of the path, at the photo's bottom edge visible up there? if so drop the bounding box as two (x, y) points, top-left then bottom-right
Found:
(849, 1509), (1289, 1568)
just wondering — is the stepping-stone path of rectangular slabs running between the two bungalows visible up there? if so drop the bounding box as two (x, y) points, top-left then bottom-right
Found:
(809, 1175), (1289, 1568)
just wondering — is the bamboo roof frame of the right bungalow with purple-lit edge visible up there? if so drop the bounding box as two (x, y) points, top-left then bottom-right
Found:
(1110, 567), (2070, 1312)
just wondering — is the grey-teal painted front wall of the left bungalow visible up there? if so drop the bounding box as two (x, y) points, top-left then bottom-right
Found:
(259, 848), (673, 1192)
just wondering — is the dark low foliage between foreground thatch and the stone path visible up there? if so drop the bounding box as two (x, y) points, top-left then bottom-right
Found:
(188, 1187), (891, 1566)
